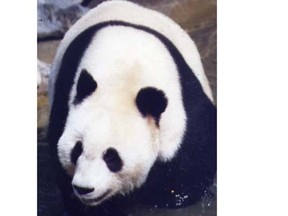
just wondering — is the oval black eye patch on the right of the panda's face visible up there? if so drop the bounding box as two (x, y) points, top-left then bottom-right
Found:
(103, 148), (123, 172)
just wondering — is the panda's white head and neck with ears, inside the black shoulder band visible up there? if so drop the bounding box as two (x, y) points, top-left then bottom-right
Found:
(57, 27), (185, 205)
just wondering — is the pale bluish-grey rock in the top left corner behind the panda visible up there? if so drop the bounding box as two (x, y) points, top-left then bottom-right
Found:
(37, 0), (89, 40)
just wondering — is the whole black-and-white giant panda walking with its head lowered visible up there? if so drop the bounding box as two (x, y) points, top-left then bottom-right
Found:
(48, 1), (216, 216)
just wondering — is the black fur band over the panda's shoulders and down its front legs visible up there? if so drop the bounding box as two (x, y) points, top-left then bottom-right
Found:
(48, 21), (216, 216)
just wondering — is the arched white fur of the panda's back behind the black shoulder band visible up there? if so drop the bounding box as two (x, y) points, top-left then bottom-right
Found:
(49, 1), (213, 103)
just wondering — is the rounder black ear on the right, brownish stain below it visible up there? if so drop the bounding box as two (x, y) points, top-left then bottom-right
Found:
(136, 87), (168, 124)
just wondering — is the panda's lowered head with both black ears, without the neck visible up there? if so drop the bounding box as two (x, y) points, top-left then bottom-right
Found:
(58, 69), (168, 205)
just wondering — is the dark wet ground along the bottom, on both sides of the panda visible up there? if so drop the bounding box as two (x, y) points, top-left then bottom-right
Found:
(37, 140), (216, 216)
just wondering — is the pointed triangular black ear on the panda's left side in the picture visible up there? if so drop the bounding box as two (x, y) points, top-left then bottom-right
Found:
(74, 69), (97, 104)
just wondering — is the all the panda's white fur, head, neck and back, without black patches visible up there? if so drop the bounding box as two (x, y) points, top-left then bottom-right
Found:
(50, 1), (212, 205)
